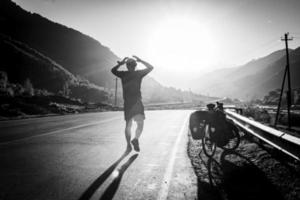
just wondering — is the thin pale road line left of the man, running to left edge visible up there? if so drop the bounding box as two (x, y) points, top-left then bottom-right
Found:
(0, 117), (121, 146)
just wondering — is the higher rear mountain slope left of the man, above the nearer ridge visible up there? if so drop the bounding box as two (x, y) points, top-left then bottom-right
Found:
(0, 0), (119, 87)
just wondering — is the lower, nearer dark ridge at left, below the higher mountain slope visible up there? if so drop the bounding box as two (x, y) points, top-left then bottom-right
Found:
(0, 34), (108, 102)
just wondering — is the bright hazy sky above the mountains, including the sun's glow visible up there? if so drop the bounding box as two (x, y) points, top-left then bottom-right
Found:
(14, 0), (300, 87)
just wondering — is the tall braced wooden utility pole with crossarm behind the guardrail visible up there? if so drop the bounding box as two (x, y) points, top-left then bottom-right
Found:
(274, 33), (293, 130)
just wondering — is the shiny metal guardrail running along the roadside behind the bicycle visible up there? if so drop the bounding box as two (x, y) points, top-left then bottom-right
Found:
(225, 110), (300, 161)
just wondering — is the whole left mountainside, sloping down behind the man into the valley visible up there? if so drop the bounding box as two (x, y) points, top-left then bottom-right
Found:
(0, 0), (213, 103)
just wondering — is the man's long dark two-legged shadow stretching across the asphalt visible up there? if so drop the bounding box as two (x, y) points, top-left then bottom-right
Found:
(79, 151), (138, 200)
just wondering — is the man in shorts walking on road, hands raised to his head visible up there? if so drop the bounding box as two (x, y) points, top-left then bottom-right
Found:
(111, 56), (153, 151)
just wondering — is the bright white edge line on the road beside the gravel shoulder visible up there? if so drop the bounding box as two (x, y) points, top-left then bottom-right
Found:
(157, 117), (188, 200)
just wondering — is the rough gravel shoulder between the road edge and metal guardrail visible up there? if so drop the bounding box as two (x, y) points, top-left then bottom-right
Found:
(188, 131), (300, 200)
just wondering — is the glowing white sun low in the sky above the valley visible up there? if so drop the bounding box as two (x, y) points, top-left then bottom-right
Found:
(149, 17), (215, 71)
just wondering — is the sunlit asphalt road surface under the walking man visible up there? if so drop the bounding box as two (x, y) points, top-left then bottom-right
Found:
(0, 110), (197, 200)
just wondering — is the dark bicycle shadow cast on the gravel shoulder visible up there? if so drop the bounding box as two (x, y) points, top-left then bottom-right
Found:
(207, 150), (283, 200)
